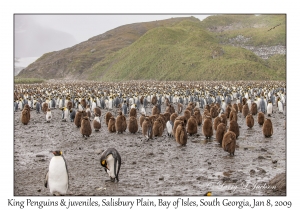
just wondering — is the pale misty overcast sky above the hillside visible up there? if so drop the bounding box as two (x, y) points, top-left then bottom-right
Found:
(14, 14), (208, 67)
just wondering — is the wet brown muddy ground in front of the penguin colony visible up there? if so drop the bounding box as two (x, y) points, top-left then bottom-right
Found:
(14, 102), (286, 196)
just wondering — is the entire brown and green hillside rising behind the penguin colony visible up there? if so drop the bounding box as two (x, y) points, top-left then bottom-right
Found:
(18, 15), (286, 81)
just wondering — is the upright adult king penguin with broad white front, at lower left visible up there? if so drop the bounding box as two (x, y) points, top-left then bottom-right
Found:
(44, 151), (69, 195)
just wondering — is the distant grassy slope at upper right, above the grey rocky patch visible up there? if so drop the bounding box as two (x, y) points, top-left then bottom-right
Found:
(202, 15), (286, 46)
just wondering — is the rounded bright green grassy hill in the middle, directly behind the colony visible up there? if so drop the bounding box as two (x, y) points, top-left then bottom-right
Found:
(90, 20), (282, 81)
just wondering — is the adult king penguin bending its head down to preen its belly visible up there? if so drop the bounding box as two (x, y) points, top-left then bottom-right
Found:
(100, 148), (122, 182)
